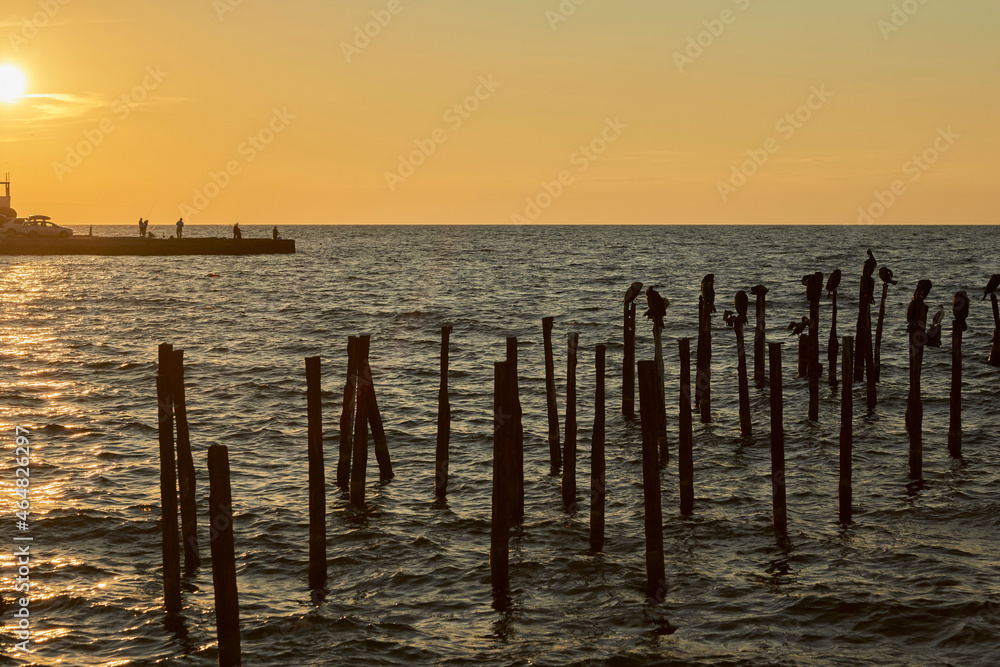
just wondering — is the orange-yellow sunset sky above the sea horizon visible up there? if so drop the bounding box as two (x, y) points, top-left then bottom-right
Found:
(0, 0), (1000, 225)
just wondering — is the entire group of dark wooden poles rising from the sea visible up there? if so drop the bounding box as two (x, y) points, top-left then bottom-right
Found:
(150, 266), (1000, 665)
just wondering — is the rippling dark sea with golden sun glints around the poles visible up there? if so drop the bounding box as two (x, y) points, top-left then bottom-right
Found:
(0, 227), (1000, 666)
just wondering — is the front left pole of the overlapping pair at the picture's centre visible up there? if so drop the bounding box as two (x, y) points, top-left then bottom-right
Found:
(490, 361), (513, 597)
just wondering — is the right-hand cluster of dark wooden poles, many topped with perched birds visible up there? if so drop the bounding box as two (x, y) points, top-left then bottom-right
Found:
(490, 262), (1000, 601)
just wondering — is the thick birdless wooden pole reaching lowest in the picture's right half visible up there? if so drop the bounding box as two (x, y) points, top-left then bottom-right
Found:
(639, 361), (667, 602)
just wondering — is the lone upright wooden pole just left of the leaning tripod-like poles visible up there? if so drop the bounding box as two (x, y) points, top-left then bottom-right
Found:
(306, 357), (326, 590)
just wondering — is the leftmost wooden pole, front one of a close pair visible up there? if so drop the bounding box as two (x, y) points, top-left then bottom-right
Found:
(156, 374), (181, 613)
